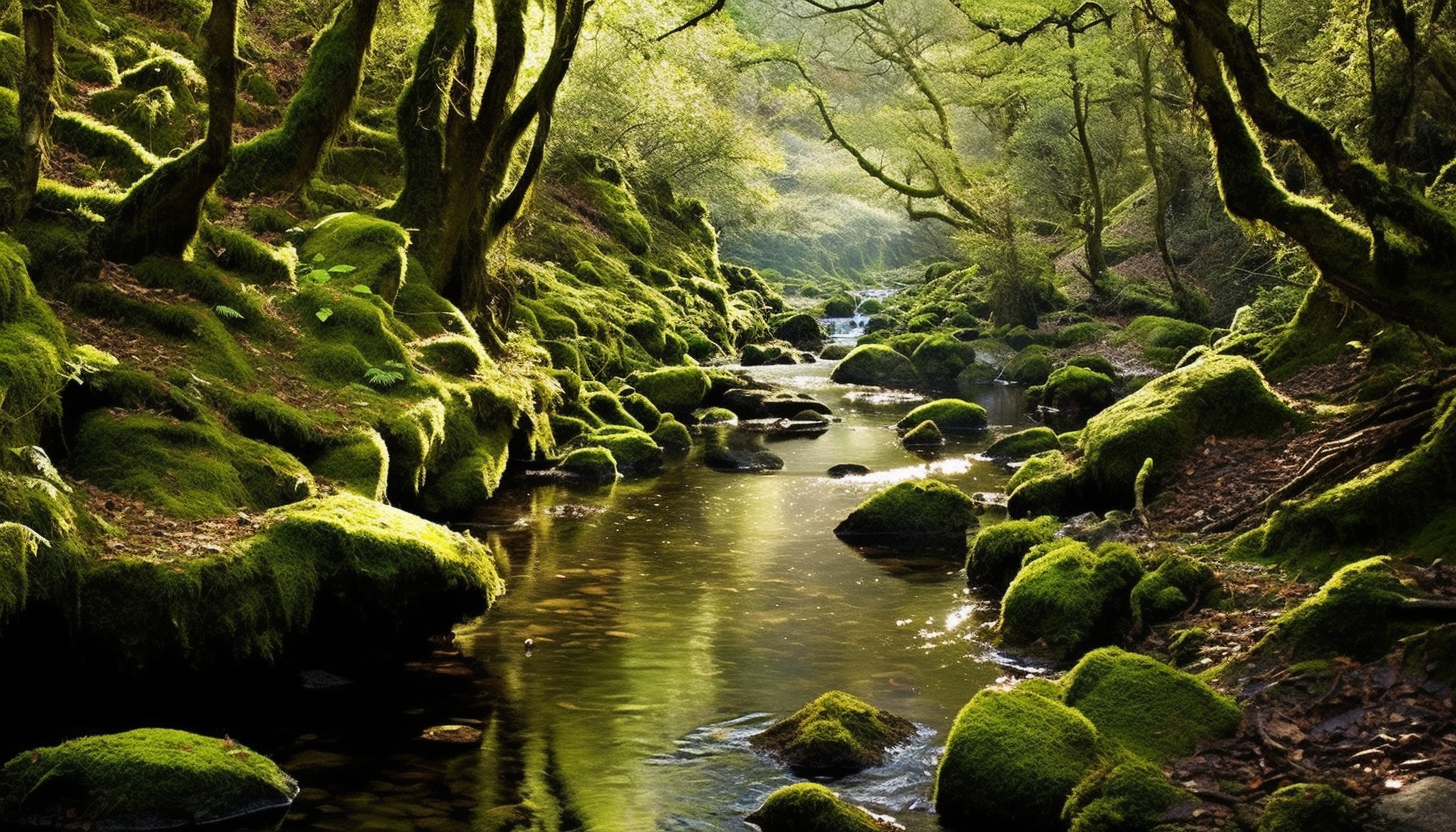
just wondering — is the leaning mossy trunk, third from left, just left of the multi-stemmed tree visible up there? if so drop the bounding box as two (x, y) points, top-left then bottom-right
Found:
(221, 0), (379, 195)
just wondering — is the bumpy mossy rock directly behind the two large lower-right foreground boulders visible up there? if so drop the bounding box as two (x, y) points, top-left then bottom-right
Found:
(999, 541), (1143, 659)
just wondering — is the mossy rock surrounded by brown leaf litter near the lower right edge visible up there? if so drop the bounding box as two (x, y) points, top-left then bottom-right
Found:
(1255, 557), (1412, 662)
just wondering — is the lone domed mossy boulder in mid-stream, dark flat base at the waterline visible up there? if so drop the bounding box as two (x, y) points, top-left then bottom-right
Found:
(834, 479), (976, 545)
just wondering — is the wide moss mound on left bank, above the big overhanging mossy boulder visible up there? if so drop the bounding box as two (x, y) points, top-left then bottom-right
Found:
(71, 412), (313, 520)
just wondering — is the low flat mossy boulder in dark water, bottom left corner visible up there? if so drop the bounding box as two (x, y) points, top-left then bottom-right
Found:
(0, 729), (298, 829)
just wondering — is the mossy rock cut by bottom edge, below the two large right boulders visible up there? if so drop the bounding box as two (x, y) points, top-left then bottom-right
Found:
(1063, 761), (1192, 832)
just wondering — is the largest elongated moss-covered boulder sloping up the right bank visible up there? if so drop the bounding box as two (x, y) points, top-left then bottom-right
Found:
(1077, 356), (1294, 510)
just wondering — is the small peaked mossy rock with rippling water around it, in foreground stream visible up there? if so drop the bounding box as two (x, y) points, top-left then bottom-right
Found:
(748, 691), (916, 777)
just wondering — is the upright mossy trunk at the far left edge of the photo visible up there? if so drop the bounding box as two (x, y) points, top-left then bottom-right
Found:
(0, 0), (55, 229)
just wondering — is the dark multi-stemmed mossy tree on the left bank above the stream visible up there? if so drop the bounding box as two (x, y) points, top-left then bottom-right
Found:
(386, 0), (585, 348)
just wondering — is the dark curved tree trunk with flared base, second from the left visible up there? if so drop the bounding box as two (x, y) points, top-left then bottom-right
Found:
(102, 0), (239, 262)
